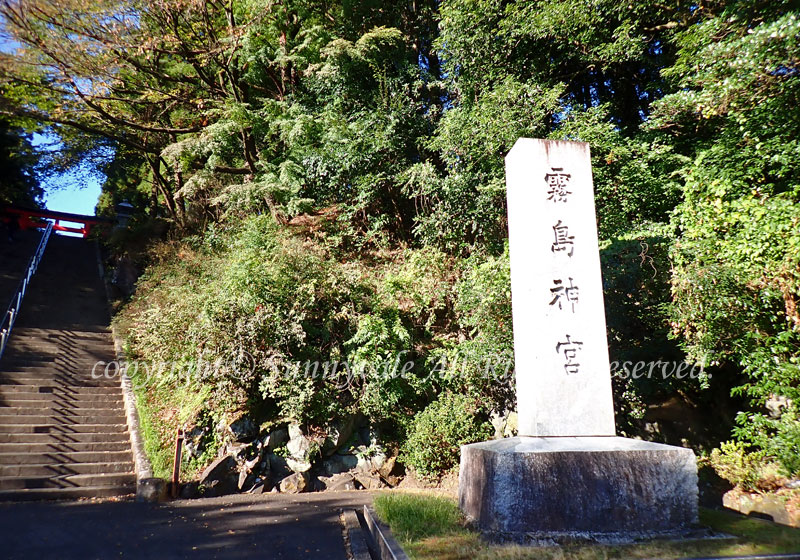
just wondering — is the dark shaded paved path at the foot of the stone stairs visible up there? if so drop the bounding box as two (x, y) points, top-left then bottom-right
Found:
(0, 491), (372, 560)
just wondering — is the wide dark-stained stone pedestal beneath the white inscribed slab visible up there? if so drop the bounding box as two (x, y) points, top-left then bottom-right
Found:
(458, 437), (697, 537)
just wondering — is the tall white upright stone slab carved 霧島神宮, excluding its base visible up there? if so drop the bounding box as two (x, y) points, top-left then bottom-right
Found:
(506, 138), (615, 437)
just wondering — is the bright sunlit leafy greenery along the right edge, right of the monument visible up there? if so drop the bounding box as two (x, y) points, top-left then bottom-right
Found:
(653, 7), (800, 473)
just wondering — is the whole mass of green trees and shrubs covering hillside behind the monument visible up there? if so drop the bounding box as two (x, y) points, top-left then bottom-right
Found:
(42, 0), (800, 482)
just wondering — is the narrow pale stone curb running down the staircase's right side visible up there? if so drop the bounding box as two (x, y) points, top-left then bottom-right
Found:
(95, 242), (162, 502)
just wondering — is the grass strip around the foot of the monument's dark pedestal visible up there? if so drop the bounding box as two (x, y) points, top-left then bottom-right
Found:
(375, 492), (800, 560)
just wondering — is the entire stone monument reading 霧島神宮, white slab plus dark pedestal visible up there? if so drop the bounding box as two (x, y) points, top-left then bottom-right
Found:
(459, 138), (697, 538)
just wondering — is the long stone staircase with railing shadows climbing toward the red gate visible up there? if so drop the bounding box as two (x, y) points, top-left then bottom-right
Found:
(0, 235), (136, 501)
